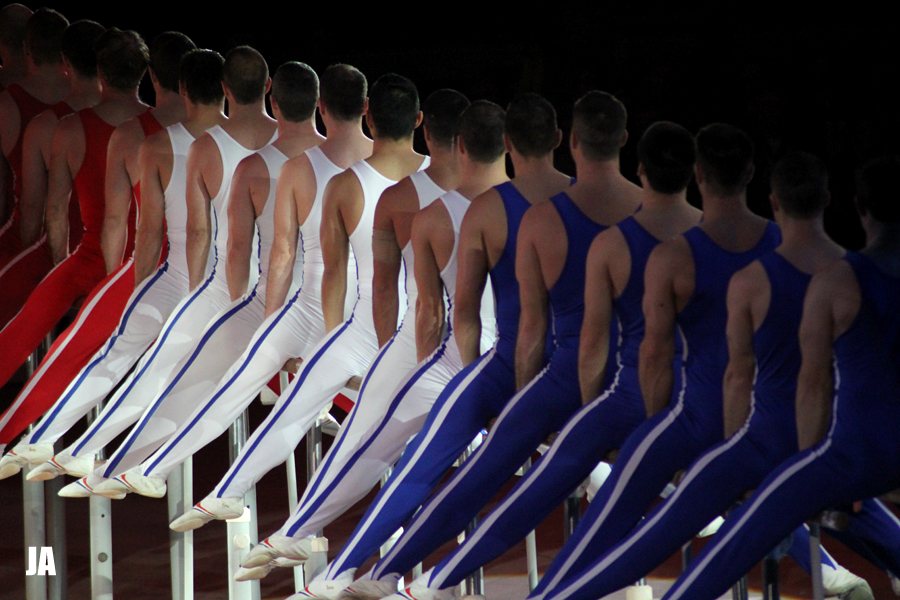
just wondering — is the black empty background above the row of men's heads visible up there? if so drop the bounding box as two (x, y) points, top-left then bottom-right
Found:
(37, 1), (898, 248)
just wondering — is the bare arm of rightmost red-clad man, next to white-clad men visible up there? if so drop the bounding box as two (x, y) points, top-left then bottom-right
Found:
(100, 126), (140, 273)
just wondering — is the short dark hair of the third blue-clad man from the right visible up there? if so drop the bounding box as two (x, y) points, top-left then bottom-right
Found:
(697, 123), (754, 194)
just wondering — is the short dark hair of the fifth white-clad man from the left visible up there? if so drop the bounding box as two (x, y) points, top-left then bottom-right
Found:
(369, 73), (419, 140)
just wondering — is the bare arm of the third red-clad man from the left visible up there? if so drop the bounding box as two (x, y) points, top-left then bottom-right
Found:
(19, 111), (57, 248)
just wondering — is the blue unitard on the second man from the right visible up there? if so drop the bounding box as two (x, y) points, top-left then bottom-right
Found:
(545, 252), (898, 599)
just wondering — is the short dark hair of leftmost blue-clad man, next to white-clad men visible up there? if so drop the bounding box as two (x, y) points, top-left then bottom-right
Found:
(506, 92), (559, 158)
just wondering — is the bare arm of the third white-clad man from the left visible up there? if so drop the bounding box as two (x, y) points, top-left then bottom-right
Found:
(225, 154), (260, 301)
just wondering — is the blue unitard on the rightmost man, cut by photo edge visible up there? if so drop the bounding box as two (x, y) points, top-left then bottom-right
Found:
(665, 253), (900, 600)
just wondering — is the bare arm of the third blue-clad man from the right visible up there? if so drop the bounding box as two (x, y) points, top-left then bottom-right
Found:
(638, 244), (677, 417)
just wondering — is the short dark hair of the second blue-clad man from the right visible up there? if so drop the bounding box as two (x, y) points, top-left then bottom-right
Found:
(769, 152), (829, 219)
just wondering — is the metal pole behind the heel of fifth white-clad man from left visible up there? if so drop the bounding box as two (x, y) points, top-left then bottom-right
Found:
(225, 411), (260, 600)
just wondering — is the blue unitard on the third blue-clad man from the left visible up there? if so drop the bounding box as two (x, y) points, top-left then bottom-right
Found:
(428, 217), (678, 588)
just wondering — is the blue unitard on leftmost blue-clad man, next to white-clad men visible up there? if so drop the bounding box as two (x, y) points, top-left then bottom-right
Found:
(326, 182), (548, 579)
